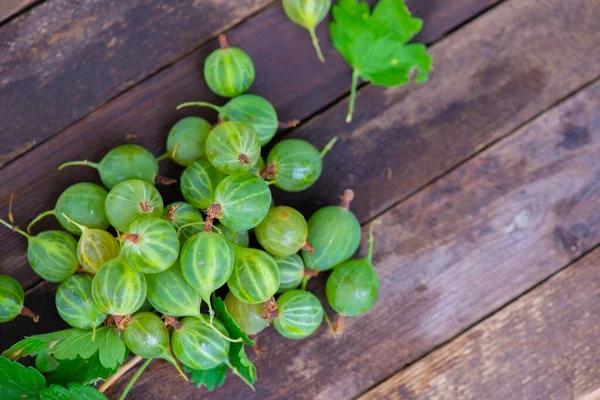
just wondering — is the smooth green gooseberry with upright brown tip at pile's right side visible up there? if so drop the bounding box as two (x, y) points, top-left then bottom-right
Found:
(302, 190), (360, 271)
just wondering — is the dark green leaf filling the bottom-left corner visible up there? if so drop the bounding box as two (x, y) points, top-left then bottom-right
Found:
(0, 357), (46, 399)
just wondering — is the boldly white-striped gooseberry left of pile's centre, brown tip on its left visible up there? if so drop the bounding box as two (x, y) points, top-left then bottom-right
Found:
(121, 218), (179, 274)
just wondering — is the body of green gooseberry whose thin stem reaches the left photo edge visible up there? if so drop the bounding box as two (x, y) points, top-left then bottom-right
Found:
(27, 231), (78, 282)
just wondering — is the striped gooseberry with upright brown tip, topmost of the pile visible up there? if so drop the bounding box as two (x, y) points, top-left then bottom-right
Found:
(204, 35), (254, 97)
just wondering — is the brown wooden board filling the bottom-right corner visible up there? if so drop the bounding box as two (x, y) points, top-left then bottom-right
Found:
(361, 250), (600, 400)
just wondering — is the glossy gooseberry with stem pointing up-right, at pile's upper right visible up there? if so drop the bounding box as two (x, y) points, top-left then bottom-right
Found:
(267, 139), (323, 192)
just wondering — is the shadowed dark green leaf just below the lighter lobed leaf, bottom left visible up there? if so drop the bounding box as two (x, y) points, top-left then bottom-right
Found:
(48, 353), (118, 385)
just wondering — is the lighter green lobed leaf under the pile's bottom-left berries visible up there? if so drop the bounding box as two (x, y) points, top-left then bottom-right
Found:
(52, 326), (127, 369)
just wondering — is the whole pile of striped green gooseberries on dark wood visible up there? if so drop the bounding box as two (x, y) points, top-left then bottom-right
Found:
(0, 31), (379, 394)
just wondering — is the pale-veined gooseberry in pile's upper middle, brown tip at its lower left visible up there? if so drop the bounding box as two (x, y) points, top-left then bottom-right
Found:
(215, 174), (271, 231)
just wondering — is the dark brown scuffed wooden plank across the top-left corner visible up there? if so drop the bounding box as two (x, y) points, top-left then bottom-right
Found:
(0, 0), (273, 166)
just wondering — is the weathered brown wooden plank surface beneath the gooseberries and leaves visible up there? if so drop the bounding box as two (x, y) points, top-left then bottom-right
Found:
(0, 0), (600, 399)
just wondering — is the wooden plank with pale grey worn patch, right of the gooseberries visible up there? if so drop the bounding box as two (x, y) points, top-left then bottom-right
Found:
(108, 72), (600, 399)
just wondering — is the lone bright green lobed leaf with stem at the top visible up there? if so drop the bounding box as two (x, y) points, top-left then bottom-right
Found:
(329, 0), (433, 122)
